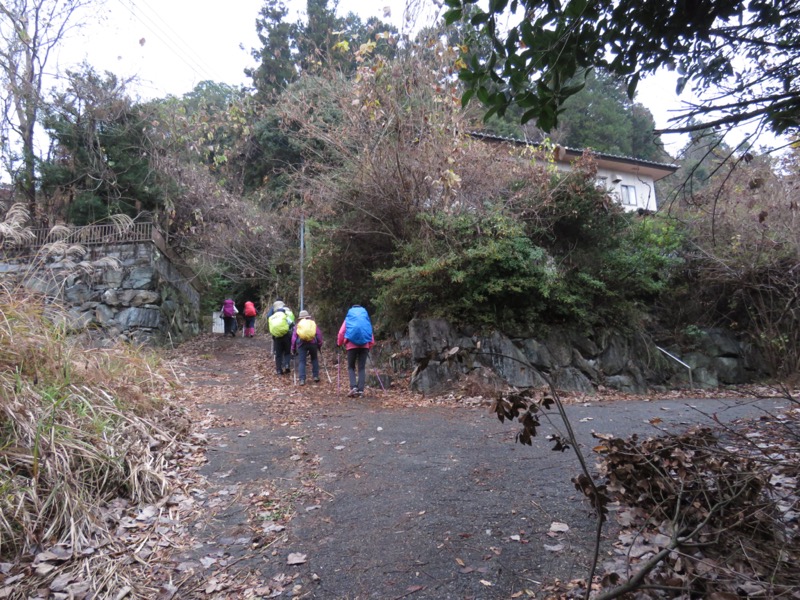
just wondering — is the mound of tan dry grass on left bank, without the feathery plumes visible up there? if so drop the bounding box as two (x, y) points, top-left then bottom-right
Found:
(0, 288), (186, 576)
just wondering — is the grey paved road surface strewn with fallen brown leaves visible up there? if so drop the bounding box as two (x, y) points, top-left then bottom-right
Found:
(169, 339), (785, 600)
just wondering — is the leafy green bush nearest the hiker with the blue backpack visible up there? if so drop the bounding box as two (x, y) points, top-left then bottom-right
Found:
(375, 213), (559, 328)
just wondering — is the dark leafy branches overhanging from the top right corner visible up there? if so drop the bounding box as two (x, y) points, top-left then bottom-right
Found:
(445, 0), (800, 143)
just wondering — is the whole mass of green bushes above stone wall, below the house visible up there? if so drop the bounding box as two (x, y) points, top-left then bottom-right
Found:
(375, 172), (681, 330)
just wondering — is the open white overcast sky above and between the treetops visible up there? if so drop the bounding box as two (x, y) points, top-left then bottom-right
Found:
(50, 0), (768, 155)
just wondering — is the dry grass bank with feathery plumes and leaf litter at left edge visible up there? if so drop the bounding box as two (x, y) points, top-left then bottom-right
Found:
(0, 205), (195, 598)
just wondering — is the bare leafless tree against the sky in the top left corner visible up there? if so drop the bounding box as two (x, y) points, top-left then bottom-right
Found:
(0, 0), (95, 219)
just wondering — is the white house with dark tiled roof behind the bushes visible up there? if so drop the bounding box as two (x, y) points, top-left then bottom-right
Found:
(470, 132), (678, 211)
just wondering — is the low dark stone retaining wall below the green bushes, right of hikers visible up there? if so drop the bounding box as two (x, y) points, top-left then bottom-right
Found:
(402, 319), (766, 394)
